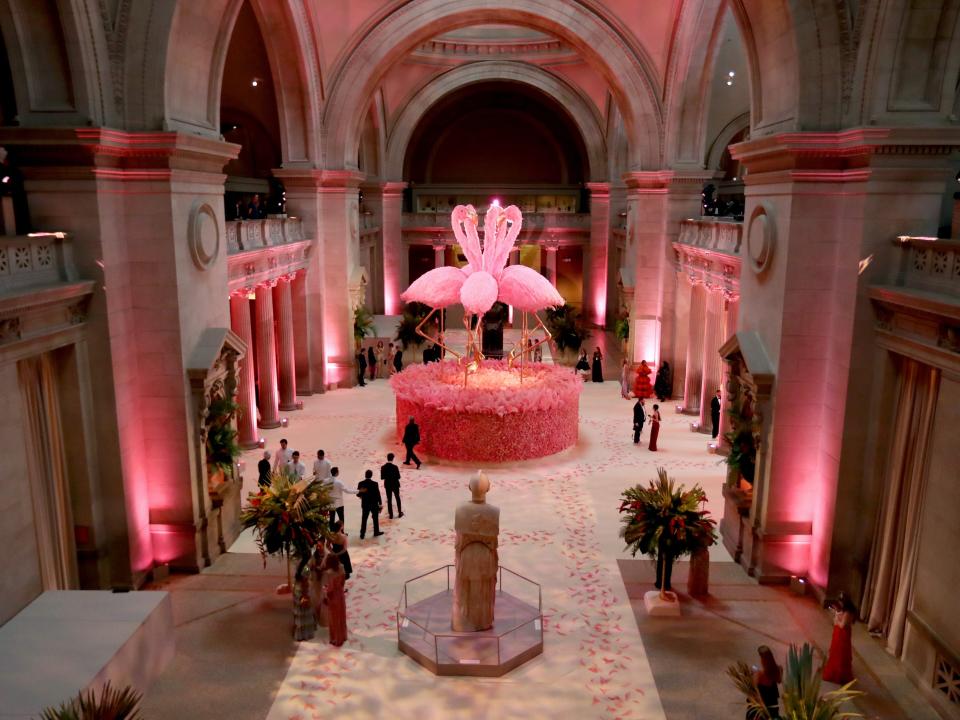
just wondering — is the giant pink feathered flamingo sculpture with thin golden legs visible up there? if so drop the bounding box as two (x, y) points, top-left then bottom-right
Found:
(401, 204), (563, 374)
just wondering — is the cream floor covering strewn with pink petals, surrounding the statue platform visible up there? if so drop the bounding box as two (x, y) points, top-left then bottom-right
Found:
(233, 380), (729, 720)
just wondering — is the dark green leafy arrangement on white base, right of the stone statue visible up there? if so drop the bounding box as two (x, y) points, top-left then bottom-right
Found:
(620, 468), (717, 558)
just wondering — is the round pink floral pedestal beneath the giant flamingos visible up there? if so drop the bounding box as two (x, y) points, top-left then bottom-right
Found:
(390, 361), (583, 462)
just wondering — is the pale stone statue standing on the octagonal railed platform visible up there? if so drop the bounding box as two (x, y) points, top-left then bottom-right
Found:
(451, 471), (500, 632)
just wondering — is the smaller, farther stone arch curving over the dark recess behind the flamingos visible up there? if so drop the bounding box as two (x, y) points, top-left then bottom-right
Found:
(386, 60), (606, 182)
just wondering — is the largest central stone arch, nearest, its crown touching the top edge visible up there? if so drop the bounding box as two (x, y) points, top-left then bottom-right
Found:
(324, 0), (662, 169)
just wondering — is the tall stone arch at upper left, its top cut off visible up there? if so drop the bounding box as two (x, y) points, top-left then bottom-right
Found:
(124, 0), (322, 166)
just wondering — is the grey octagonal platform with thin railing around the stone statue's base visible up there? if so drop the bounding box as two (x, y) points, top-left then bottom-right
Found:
(397, 565), (543, 677)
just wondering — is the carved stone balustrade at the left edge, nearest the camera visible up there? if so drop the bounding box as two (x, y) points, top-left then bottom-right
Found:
(0, 232), (77, 293)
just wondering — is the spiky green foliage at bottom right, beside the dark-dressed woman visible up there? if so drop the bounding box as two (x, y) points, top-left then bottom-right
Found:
(727, 643), (863, 720)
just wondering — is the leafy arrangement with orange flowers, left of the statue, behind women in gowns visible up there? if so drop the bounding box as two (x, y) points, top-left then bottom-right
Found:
(240, 470), (333, 572)
